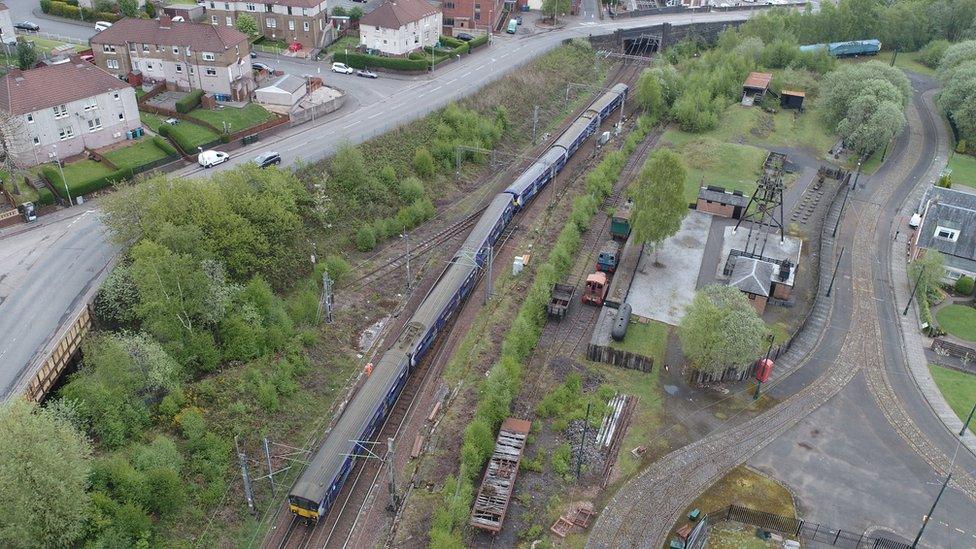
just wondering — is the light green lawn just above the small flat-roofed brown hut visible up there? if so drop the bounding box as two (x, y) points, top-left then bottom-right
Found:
(664, 129), (768, 203)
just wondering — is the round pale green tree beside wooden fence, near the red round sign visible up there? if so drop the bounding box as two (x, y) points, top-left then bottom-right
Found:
(678, 285), (768, 374)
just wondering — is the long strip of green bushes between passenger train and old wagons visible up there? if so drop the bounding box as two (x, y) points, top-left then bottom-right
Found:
(430, 114), (653, 548)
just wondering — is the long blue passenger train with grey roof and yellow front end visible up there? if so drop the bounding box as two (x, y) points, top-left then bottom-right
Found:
(288, 83), (629, 521)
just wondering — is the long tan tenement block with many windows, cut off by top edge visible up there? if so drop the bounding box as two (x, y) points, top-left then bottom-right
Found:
(206, 0), (335, 49)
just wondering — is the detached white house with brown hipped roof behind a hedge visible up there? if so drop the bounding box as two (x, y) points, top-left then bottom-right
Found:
(359, 0), (444, 55)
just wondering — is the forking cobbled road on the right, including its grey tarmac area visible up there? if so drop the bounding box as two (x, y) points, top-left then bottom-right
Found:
(589, 67), (976, 547)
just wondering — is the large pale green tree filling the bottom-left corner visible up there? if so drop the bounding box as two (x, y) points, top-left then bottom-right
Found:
(0, 397), (91, 547)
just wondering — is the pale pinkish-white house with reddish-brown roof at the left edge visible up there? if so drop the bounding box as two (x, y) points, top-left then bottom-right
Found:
(0, 57), (141, 166)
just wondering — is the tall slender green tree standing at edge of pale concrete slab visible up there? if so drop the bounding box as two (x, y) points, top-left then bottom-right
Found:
(630, 149), (688, 263)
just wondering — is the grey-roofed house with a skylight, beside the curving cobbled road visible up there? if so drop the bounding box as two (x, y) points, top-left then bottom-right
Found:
(909, 187), (976, 282)
